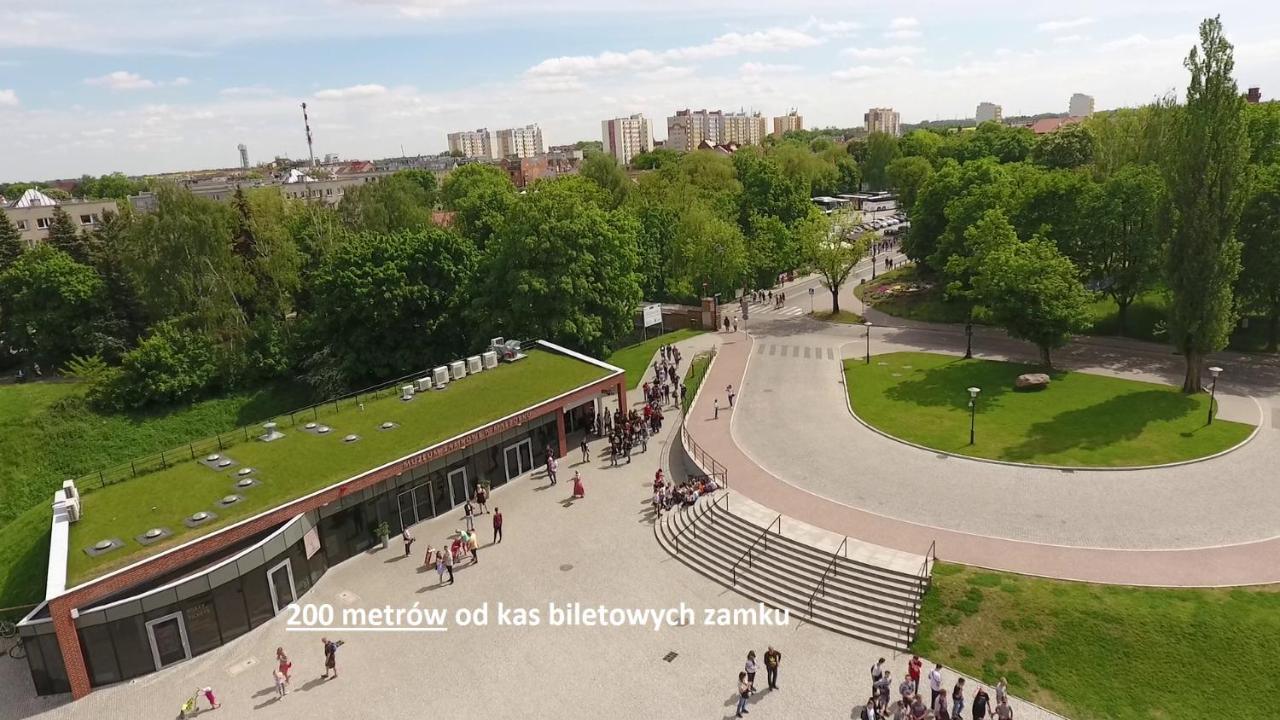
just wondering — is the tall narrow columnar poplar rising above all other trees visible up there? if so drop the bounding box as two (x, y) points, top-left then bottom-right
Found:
(1166, 18), (1249, 392)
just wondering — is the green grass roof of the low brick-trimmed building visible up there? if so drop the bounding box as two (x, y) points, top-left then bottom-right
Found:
(67, 351), (607, 584)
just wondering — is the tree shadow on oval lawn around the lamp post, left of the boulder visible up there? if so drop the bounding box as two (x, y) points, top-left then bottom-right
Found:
(884, 357), (1062, 415)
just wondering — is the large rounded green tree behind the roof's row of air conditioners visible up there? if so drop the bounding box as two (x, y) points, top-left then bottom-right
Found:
(480, 176), (640, 355)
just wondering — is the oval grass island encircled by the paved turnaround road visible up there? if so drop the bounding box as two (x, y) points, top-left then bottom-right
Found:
(845, 352), (1253, 468)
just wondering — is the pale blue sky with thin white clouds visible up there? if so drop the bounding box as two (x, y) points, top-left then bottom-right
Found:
(0, 0), (1280, 182)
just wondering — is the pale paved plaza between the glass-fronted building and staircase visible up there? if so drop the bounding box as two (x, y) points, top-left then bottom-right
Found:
(0, 334), (1056, 720)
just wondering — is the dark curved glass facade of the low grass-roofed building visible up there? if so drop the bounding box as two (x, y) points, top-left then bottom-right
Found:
(22, 413), (556, 694)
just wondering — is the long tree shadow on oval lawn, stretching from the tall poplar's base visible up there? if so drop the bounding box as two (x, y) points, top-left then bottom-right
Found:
(1001, 389), (1197, 461)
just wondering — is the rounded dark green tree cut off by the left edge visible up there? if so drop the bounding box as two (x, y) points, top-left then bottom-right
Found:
(0, 243), (102, 368)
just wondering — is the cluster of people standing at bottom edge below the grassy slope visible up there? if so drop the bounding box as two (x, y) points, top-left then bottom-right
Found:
(860, 655), (1014, 720)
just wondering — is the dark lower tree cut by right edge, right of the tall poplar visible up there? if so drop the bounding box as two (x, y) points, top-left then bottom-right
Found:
(1238, 165), (1280, 352)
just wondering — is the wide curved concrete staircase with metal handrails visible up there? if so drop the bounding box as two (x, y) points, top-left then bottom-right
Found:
(654, 492), (931, 651)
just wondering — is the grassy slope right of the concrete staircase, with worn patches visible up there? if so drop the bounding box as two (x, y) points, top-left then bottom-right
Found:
(913, 562), (1280, 720)
